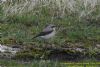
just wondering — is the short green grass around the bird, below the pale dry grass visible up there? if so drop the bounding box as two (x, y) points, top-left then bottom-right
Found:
(0, 15), (100, 45)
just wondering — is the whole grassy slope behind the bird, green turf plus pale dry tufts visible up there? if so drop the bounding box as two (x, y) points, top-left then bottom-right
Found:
(0, 0), (100, 61)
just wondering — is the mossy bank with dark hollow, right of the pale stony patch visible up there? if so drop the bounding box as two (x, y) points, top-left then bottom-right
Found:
(14, 44), (100, 61)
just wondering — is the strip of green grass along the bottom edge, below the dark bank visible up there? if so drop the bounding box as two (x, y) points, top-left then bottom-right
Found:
(0, 60), (100, 67)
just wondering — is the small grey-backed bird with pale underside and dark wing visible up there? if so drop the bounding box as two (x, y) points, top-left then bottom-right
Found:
(34, 24), (56, 40)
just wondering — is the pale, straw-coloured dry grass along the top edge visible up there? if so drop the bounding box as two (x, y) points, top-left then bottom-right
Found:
(2, 0), (100, 18)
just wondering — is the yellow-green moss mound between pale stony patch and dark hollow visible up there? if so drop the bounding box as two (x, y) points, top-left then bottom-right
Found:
(15, 48), (46, 60)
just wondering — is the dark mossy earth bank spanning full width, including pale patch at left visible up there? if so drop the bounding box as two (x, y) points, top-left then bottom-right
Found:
(0, 45), (100, 61)
